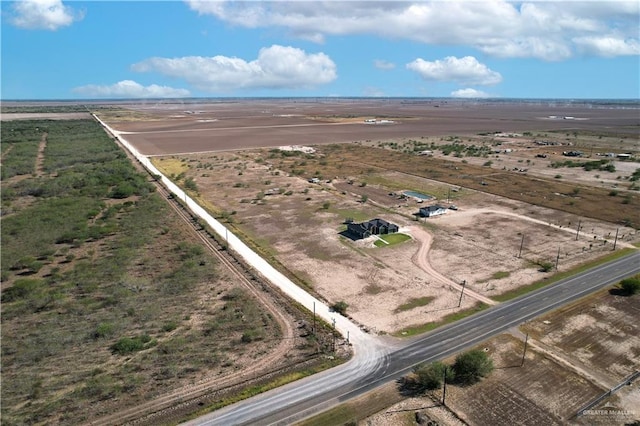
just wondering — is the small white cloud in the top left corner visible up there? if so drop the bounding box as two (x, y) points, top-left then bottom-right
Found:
(10, 0), (84, 31)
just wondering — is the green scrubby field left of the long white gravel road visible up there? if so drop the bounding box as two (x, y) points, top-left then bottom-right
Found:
(1, 120), (340, 425)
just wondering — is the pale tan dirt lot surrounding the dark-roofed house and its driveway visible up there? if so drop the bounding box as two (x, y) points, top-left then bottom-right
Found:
(149, 150), (640, 333)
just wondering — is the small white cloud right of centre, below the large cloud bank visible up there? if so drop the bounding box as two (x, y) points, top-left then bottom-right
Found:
(407, 56), (502, 85)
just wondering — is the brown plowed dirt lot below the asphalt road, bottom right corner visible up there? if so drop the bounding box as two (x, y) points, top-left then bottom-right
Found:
(359, 291), (640, 426)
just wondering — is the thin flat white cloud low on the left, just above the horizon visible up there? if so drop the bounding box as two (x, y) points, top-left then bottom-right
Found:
(73, 80), (190, 98)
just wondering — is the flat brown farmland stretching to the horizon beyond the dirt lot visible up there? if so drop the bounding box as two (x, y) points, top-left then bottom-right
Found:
(100, 100), (640, 155)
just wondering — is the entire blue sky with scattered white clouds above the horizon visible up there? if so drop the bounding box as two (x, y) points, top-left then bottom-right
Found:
(0, 0), (640, 99)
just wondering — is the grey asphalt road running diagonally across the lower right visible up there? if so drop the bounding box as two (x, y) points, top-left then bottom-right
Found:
(182, 252), (640, 425)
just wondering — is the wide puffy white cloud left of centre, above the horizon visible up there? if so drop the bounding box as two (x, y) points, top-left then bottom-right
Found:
(131, 45), (337, 92)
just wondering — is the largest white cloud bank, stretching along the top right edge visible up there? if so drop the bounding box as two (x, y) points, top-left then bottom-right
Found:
(187, 0), (640, 61)
